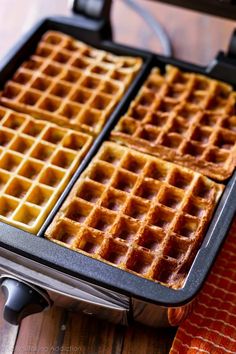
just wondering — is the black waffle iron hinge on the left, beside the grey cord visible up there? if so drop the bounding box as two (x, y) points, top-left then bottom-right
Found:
(69, 0), (112, 41)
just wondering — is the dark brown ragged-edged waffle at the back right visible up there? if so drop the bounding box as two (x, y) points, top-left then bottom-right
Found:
(112, 66), (236, 180)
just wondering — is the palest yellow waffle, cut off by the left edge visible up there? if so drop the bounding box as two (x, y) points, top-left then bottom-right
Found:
(0, 107), (92, 234)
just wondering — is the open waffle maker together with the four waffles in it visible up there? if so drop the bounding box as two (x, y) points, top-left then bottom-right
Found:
(0, 1), (236, 326)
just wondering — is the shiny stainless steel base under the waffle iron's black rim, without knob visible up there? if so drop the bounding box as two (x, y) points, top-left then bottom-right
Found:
(0, 249), (192, 327)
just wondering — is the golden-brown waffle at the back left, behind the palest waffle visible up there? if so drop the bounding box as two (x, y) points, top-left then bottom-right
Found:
(0, 31), (142, 135)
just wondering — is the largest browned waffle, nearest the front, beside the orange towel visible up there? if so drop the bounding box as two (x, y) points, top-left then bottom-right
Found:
(46, 142), (223, 288)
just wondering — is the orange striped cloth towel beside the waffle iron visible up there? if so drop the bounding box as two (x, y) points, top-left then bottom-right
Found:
(170, 219), (236, 354)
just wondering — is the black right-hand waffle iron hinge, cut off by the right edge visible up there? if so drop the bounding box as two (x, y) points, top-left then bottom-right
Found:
(206, 29), (236, 85)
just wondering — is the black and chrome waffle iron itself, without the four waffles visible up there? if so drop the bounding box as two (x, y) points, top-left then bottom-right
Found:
(0, 0), (236, 327)
